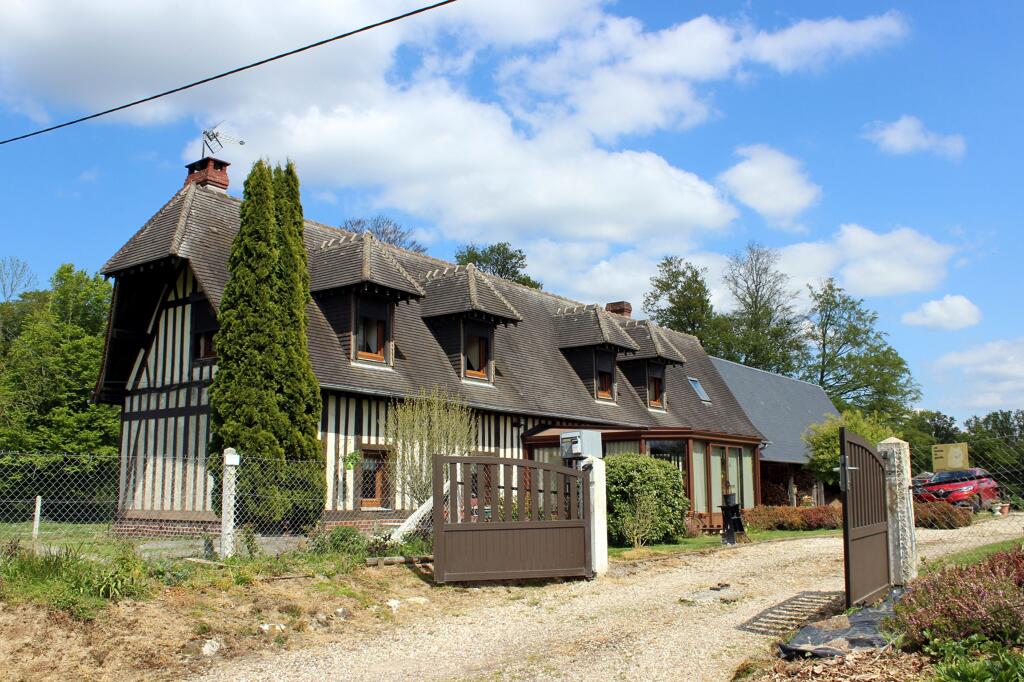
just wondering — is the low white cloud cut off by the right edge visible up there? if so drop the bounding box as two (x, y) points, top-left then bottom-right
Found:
(936, 338), (1024, 410)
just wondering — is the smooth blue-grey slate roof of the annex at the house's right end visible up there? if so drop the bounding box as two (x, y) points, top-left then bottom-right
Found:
(711, 357), (839, 464)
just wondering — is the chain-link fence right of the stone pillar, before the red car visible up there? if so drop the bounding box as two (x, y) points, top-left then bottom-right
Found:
(911, 437), (1024, 560)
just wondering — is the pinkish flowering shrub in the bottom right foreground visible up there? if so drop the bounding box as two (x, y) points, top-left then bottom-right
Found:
(892, 550), (1024, 647)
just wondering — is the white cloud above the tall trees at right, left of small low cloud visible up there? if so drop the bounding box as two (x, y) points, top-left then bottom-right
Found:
(835, 224), (954, 296)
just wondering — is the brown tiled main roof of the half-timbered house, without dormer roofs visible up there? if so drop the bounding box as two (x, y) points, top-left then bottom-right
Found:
(100, 185), (761, 438)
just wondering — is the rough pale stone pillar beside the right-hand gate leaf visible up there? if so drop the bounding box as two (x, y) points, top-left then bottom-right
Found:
(879, 437), (918, 587)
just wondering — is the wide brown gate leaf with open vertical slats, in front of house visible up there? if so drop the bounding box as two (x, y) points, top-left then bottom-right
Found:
(433, 455), (593, 583)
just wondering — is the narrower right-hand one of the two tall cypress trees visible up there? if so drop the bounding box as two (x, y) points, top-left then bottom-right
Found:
(273, 163), (327, 527)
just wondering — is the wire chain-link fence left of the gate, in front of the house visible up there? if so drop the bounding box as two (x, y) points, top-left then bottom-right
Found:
(0, 452), (432, 559)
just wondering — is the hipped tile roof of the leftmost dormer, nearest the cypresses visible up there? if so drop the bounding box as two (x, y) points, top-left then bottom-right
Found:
(309, 232), (425, 298)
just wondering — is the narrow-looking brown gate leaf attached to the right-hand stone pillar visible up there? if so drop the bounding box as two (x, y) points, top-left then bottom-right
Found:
(839, 428), (890, 607)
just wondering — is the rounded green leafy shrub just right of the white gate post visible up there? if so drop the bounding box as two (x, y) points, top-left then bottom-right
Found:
(605, 455), (690, 546)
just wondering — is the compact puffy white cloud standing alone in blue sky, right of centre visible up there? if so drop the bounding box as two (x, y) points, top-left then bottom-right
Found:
(718, 144), (821, 227)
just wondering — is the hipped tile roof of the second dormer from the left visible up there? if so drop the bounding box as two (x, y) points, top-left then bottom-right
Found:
(421, 264), (522, 324)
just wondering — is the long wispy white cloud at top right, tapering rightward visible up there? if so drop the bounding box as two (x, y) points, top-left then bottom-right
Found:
(499, 12), (907, 140)
